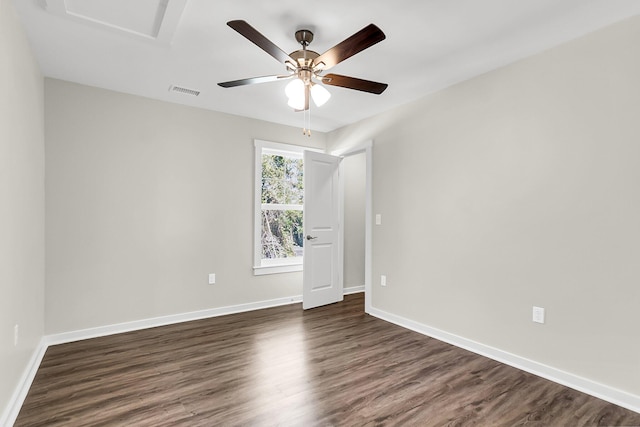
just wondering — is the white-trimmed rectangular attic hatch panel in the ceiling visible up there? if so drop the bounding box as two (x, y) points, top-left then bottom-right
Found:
(46, 0), (187, 44)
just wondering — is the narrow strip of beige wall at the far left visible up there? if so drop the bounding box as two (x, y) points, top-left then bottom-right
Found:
(0, 0), (44, 418)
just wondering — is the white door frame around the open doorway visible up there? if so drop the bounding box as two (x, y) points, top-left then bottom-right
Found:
(331, 140), (373, 313)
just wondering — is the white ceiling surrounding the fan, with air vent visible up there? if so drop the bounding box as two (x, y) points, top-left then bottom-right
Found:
(14, 0), (640, 131)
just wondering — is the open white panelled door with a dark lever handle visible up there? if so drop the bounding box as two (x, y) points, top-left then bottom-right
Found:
(302, 151), (343, 310)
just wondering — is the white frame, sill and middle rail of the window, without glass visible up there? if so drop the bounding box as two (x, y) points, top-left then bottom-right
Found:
(253, 139), (324, 276)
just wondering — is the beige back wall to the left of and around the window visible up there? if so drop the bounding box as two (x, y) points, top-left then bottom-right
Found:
(45, 79), (325, 334)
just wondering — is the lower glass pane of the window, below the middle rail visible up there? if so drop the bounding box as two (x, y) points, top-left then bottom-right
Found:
(262, 209), (304, 258)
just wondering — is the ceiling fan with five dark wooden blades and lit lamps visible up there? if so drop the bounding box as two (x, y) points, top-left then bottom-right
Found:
(218, 20), (388, 111)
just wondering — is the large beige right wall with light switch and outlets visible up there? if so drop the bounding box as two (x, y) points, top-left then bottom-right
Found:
(329, 18), (640, 396)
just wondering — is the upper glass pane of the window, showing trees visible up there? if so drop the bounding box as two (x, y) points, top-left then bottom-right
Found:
(261, 154), (304, 205)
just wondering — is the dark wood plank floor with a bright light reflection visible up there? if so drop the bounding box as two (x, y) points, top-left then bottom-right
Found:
(15, 294), (640, 427)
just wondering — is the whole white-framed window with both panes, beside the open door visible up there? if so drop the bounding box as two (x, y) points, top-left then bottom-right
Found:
(253, 140), (312, 274)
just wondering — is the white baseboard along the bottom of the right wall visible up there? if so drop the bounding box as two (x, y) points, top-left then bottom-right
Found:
(369, 307), (640, 413)
